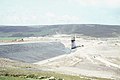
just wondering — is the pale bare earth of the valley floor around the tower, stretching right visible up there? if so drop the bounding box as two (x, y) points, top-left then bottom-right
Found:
(34, 37), (120, 80)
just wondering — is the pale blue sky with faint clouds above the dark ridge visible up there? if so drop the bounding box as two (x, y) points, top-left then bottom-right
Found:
(0, 0), (120, 25)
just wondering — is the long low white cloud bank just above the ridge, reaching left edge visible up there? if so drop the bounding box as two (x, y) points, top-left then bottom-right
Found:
(0, 12), (80, 25)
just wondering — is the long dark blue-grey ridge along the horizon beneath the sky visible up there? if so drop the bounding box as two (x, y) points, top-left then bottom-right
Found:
(0, 24), (120, 37)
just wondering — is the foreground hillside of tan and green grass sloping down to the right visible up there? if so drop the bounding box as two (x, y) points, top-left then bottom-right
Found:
(0, 58), (110, 80)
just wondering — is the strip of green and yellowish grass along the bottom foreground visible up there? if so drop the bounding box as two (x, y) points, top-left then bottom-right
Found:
(0, 68), (110, 80)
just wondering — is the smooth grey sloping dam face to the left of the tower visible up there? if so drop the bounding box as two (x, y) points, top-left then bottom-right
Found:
(0, 42), (69, 63)
